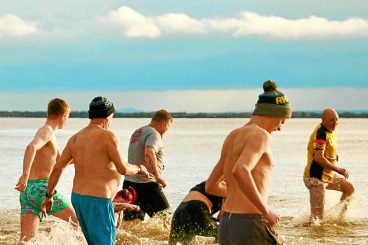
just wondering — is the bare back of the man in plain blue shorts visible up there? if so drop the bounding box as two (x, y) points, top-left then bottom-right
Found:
(67, 125), (120, 198)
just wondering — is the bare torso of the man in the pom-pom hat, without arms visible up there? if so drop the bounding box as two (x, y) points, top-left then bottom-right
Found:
(223, 124), (273, 214)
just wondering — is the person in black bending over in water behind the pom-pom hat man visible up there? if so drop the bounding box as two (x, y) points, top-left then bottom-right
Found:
(169, 181), (226, 245)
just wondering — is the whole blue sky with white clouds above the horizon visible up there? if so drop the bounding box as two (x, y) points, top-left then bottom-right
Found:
(0, 0), (368, 112)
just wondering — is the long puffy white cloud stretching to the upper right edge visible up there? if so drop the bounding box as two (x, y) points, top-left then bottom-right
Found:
(105, 6), (368, 39)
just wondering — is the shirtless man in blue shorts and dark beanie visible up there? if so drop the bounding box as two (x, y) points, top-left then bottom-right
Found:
(42, 97), (148, 244)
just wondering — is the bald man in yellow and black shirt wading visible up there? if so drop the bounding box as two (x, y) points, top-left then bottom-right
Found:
(304, 108), (354, 221)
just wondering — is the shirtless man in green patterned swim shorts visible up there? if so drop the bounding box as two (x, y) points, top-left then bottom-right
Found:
(16, 98), (78, 244)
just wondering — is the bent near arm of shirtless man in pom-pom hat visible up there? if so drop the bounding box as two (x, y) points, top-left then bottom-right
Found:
(232, 134), (279, 227)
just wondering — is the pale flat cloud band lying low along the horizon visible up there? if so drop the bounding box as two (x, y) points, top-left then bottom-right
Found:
(0, 88), (368, 112)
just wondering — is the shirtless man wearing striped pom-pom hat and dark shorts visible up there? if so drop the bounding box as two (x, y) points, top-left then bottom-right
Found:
(206, 81), (291, 244)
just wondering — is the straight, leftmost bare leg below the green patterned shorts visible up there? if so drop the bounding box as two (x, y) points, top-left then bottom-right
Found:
(18, 214), (40, 244)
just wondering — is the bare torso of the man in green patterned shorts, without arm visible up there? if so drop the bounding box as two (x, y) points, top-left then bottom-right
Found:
(29, 125), (60, 180)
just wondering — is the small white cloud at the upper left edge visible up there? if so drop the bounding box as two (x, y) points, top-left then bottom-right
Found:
(0, 14), (38, 38)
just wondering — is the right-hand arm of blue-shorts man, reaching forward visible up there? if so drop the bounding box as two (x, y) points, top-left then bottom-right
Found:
(107, 131), (148, 177)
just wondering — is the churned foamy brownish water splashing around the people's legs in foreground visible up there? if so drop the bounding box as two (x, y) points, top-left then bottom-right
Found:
(0, 202), (368, 245)
